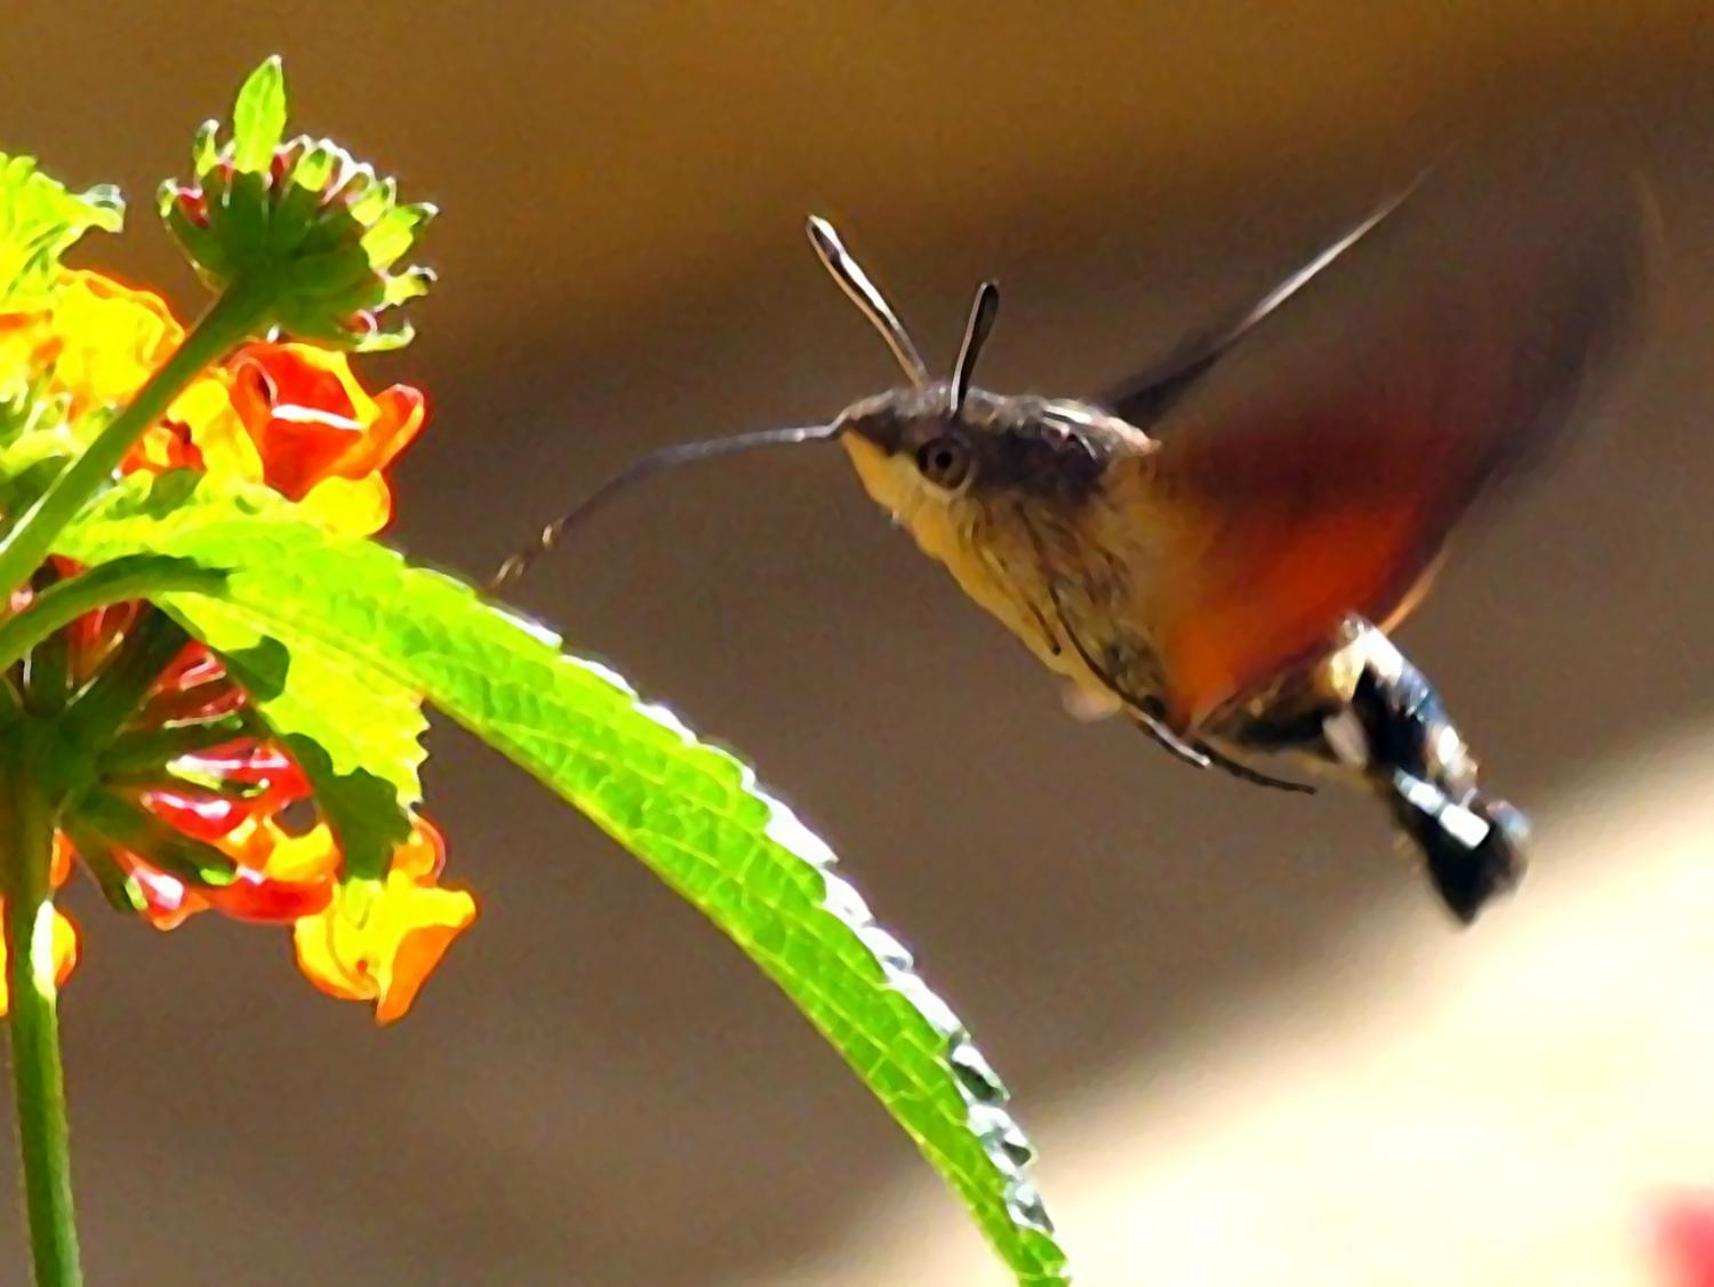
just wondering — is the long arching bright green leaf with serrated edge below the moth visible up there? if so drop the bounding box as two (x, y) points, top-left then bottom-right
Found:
(58, 488), (1066, 1284)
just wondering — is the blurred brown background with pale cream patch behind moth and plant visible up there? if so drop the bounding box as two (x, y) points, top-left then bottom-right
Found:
(0, 0), (1714, 1287)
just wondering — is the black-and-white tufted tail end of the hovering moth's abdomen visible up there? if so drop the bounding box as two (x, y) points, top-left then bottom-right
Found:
(1238, 620), (1529, 924)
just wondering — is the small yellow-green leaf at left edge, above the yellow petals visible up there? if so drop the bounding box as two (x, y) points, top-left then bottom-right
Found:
(0, 153), (125, 308)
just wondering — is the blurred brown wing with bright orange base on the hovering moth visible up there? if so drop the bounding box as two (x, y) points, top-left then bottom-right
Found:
(1116, 149), (1649, 728)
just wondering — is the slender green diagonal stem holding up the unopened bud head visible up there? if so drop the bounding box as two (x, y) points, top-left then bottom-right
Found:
(0, 278), (276, 603)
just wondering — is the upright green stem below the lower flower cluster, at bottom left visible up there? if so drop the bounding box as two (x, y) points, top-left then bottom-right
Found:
(0, 728), (82, 1287)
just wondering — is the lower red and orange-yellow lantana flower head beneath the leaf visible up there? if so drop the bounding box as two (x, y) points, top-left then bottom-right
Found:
(41, 605), (476, 1023)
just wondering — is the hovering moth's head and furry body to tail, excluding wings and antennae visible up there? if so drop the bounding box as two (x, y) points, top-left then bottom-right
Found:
(840, 386), (1525, 920)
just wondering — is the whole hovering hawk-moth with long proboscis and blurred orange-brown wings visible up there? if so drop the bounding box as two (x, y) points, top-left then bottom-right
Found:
(495, 161), (1642, 922)
